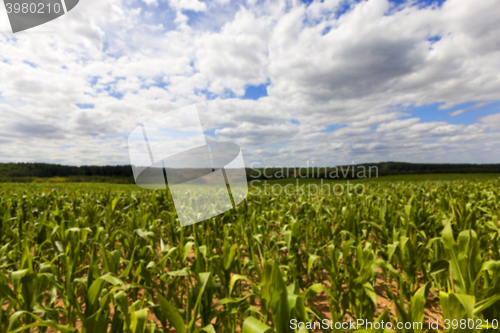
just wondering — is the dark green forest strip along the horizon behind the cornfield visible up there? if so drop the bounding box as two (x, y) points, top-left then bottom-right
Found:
(0, 162), (500, 183)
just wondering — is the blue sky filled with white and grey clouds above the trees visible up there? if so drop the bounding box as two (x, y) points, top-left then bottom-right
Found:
(0, 0), (500, 167)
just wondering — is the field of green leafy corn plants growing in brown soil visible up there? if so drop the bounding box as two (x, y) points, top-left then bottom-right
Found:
(0, 174), (500, 333)
